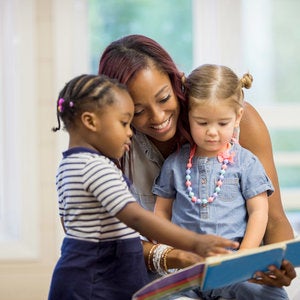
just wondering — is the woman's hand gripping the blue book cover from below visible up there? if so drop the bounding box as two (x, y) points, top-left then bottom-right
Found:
(249, 260), (296, 287)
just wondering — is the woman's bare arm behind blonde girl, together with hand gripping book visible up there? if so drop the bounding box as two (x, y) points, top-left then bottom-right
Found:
(239, 103), (296, 287)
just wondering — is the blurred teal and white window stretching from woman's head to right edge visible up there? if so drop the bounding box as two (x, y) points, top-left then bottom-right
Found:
(89, 0), (300, 230)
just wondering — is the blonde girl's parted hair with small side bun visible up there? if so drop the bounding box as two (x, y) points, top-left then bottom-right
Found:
(184, 64), (253, 110)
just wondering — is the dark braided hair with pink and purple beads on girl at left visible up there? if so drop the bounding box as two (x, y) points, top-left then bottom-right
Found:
(52, 74), (127, 132)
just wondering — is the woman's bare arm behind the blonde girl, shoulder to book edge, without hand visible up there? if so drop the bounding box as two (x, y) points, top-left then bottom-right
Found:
(239, 103), (294, 244)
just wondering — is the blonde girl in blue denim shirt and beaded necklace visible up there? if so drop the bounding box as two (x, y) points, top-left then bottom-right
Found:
(153, 65), (288, 300)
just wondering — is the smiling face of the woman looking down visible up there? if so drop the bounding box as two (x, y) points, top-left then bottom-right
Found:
(128, 67), (179, 142)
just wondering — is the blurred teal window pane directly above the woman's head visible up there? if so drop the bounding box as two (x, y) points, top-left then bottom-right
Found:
(89, 0), (193, 73)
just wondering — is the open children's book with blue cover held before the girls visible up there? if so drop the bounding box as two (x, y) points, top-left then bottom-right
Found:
(132, 238), (300, 300)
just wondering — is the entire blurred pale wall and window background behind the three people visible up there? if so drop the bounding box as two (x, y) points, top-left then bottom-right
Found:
(0, 0), (300, 300)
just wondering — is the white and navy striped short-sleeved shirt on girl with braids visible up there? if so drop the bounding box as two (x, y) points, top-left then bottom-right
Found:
(56, 147), (139, 242)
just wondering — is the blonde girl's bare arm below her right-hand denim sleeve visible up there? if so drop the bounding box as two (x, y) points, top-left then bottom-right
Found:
(240, 192), (268, 249)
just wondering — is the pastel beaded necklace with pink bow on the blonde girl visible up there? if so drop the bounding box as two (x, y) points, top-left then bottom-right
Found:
(185, 143), (235, 219)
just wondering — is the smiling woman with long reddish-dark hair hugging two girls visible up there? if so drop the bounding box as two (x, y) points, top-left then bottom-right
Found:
(99, 35), (296, 286)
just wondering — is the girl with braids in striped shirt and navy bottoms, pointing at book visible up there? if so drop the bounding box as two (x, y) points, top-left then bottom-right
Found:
(49, 75), (238, 300)
